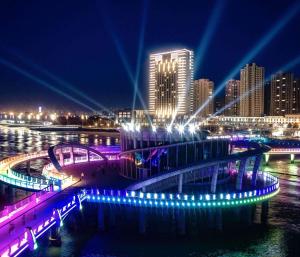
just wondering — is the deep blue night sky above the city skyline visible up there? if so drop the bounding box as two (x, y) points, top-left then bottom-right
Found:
(0, 0), (300, 110)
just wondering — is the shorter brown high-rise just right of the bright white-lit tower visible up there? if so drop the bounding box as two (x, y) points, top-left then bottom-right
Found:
(192, 79), (214, 117)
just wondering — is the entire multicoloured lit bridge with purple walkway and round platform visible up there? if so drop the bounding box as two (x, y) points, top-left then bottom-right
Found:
(0, 133), (279, 257)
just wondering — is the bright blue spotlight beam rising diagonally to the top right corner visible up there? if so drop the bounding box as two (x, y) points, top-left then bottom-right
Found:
(185, 2), (300, 126)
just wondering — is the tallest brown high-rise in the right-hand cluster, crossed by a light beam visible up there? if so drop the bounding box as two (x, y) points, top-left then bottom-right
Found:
(240, 63), (265, 117)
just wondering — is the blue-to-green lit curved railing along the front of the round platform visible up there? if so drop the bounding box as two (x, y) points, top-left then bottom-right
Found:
(86, 172), (279, 207)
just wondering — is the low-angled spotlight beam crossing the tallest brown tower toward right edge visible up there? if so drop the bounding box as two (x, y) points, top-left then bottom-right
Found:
(208, 55), (300, 119)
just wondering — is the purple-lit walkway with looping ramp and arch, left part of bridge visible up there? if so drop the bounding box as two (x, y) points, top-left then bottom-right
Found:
(0, 144), (115, 257)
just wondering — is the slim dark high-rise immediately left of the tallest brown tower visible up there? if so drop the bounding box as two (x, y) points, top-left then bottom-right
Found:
(225, 79), (240, 116)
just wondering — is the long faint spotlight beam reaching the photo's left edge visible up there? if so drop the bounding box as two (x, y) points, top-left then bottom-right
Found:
(0, 57), (96, 112)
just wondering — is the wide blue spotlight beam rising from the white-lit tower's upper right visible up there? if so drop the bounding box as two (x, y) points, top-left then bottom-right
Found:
(195, 0), (225, 71)
